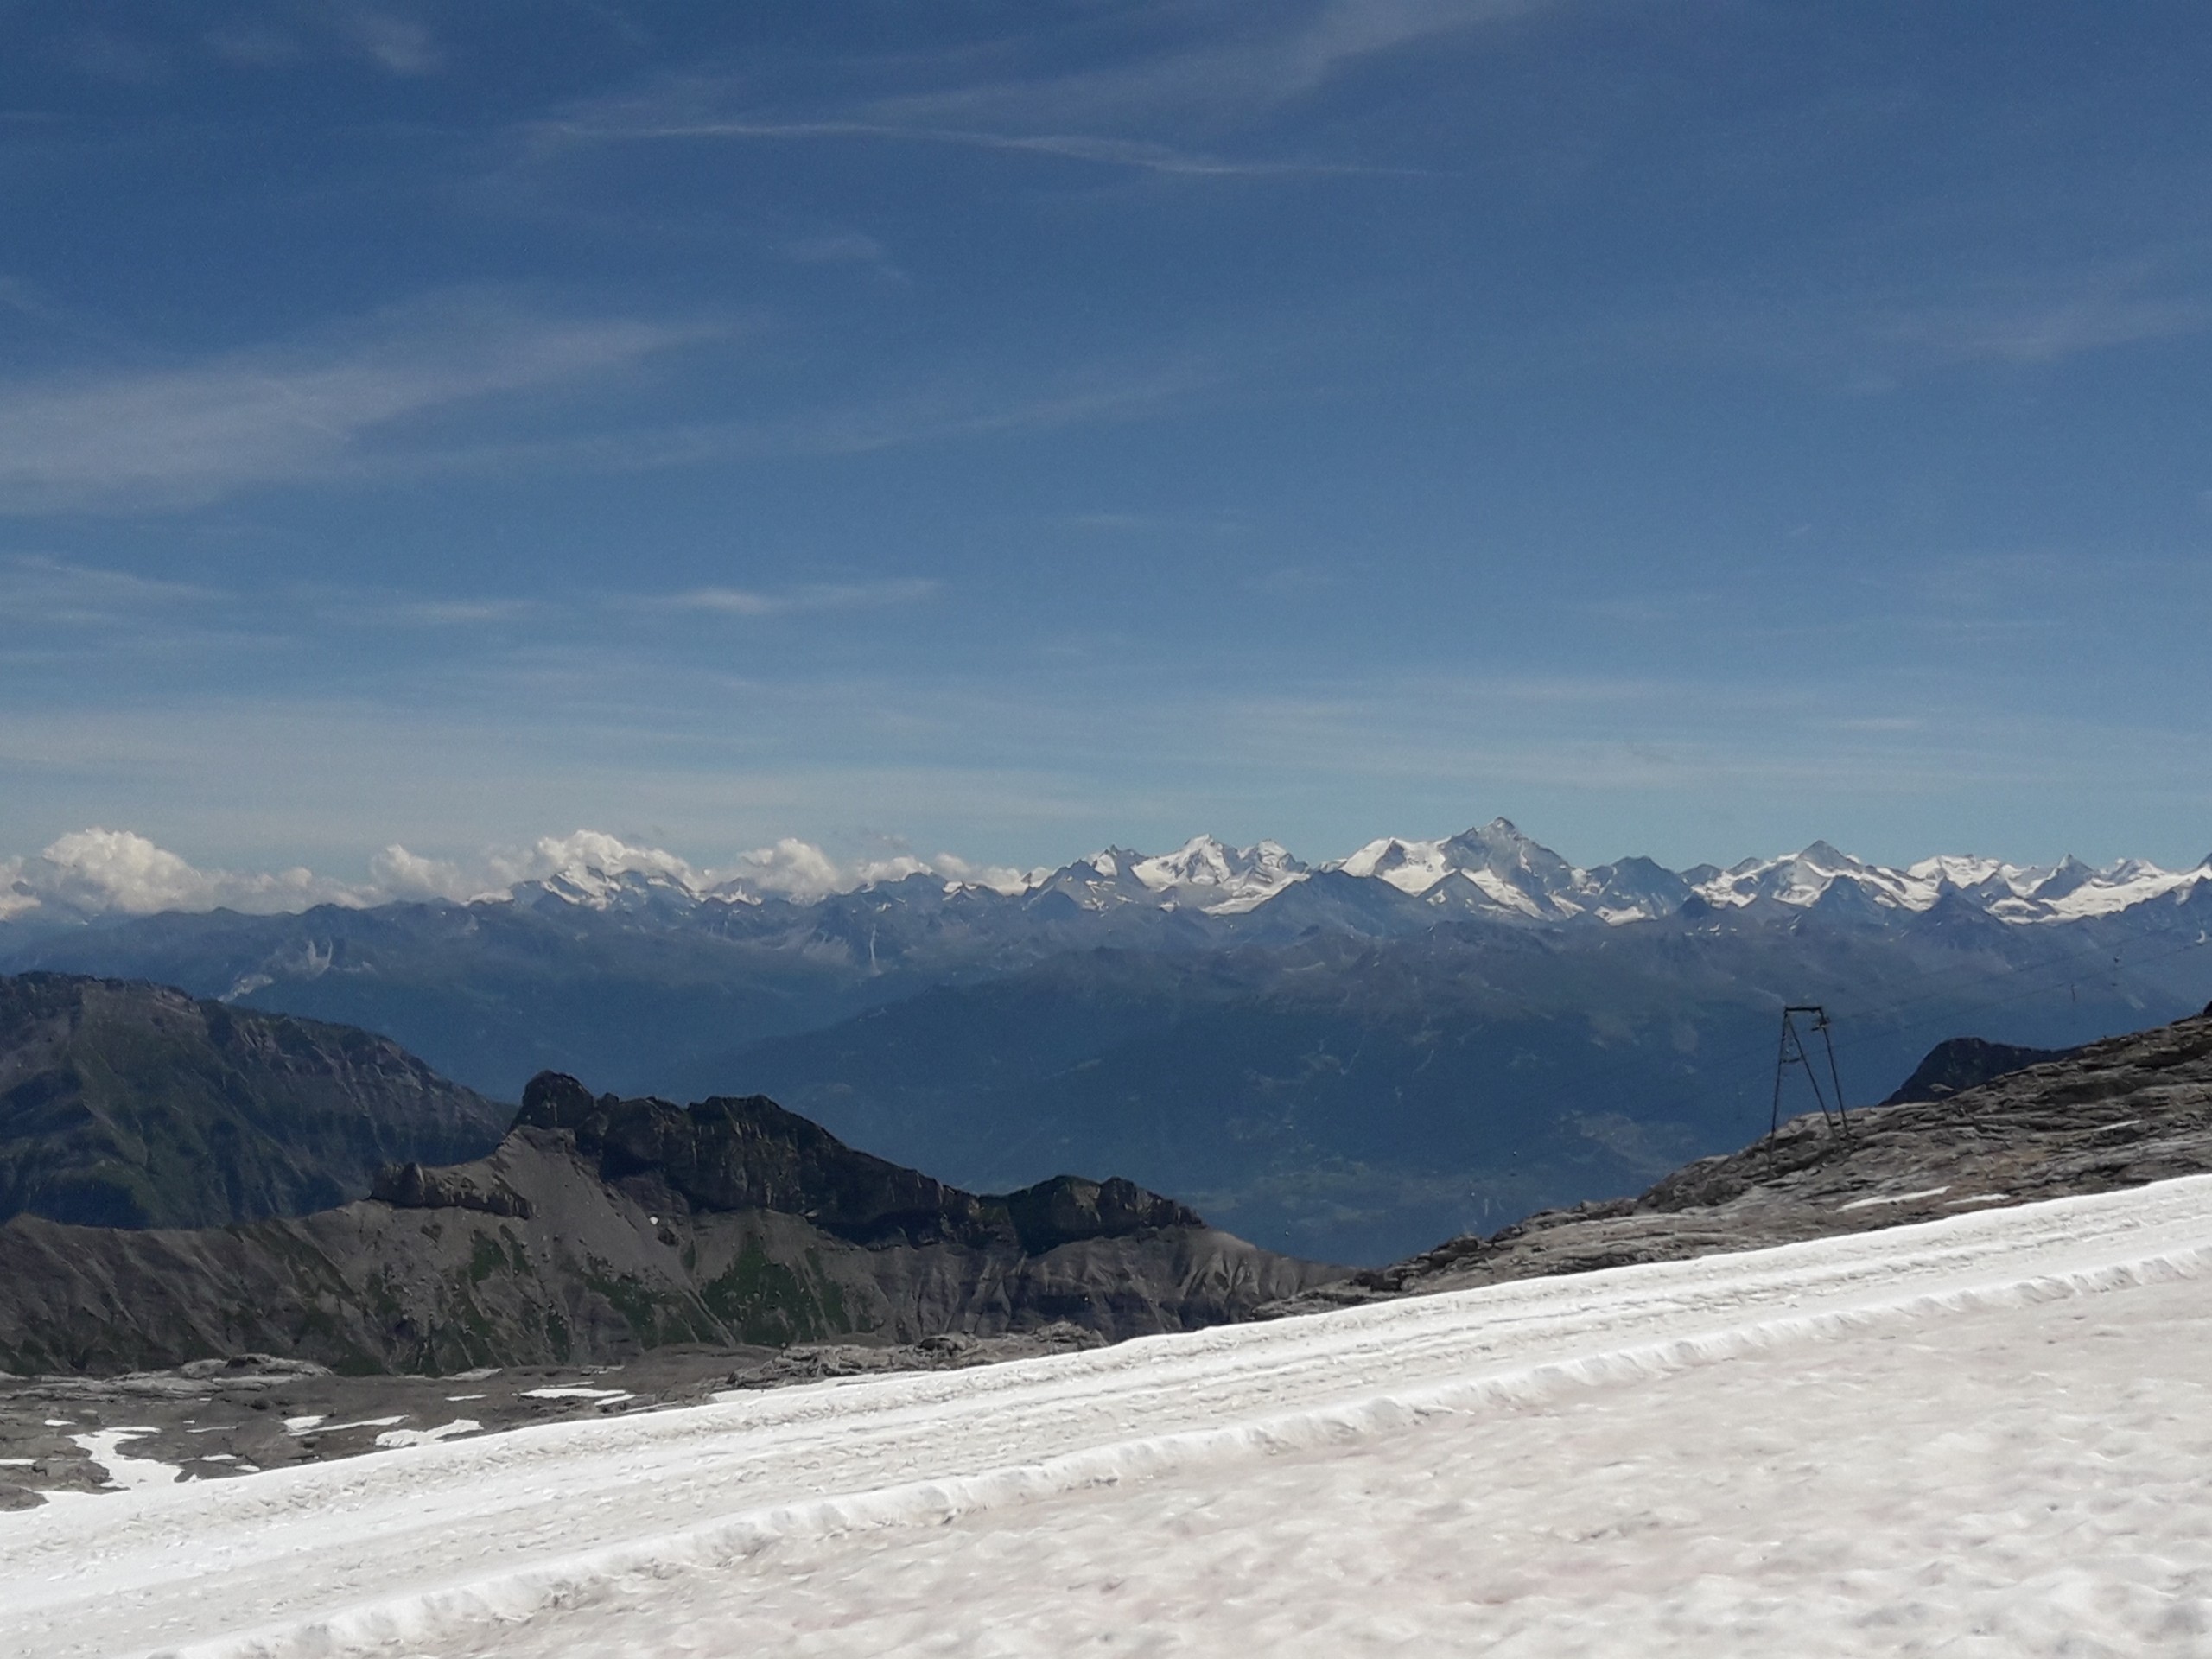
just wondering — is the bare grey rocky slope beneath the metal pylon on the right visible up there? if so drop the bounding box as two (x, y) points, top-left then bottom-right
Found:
(1268, 1008), (2212, 1314)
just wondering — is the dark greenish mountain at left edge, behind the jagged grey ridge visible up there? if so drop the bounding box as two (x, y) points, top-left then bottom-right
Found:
(0, 973), (509, 1228)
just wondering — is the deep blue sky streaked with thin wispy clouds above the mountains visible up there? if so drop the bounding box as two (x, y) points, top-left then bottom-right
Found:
(0, 0), (2212, 874)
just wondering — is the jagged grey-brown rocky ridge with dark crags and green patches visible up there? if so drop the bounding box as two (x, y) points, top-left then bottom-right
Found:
(0, 1075), (1343, 1371)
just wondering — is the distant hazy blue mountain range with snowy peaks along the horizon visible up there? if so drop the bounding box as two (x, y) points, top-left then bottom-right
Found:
(0, 821), (2212, 1263)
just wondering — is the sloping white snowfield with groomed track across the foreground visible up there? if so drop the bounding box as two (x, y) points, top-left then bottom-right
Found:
(0, 1177), (2212, 1659)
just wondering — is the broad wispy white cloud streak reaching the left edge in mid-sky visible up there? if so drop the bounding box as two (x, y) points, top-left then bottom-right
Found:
(0, 301), (710, 513)
